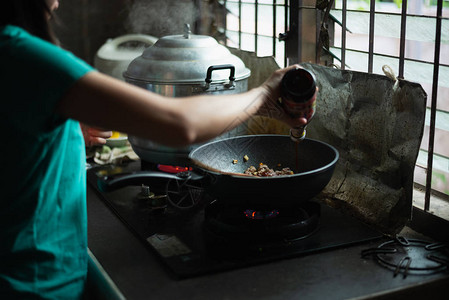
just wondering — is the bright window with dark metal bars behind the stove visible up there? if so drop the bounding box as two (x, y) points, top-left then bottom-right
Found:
(217, 0), (449, 227)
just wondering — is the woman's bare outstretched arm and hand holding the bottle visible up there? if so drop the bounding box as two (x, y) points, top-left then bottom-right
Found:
(57, 66), (306, 146)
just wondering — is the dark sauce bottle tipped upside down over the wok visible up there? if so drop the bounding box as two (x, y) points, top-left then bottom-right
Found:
(281, 68), (316, 142)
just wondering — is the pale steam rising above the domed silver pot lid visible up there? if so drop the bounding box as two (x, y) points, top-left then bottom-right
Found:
(124, 0), (199, 37)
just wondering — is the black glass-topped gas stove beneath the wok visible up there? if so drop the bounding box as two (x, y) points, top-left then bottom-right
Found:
(87, 161), (382, 278)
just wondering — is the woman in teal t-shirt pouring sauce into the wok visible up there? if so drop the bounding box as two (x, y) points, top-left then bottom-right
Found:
(0, 0), (307, 299)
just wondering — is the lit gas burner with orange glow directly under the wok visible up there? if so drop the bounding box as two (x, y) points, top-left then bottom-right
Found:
(204, 200), (320, 242)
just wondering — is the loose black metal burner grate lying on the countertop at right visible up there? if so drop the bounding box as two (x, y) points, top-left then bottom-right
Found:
(362, 236), (449, 278)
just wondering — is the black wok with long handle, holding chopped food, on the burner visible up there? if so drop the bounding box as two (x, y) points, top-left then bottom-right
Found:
(99, 135), (339, 205)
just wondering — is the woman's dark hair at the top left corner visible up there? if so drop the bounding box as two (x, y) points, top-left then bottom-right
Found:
(0, 0), (58, 44)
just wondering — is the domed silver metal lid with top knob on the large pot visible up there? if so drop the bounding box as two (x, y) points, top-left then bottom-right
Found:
(123, 25), (251, 84)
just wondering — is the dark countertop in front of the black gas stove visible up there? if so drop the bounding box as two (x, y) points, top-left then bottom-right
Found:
(87, 187), (449, 300)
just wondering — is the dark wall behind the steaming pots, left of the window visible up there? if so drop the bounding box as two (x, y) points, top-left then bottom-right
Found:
(56, 0), (200, 64)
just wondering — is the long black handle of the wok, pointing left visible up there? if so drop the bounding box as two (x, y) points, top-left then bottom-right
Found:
(97, 171), (197, 192)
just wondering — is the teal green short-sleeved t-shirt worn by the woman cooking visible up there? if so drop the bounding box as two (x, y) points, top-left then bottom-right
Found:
(0, 26), (93, 299)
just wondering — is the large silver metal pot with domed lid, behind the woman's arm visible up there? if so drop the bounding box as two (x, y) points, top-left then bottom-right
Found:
(123, 26), (251, 165)
